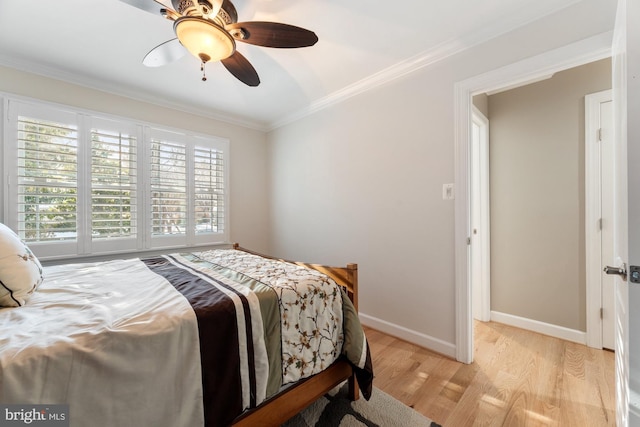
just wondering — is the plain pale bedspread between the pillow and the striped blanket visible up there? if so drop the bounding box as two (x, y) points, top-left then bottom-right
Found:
(0, 260), (204, 427)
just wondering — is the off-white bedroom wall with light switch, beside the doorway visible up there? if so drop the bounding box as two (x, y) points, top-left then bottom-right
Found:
(269, 0), (615, 355)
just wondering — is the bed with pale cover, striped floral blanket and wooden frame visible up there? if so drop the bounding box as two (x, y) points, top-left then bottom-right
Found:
(0, 231), (373, 427)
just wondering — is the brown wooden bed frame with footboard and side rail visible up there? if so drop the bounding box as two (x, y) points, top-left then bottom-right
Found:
(233, 243), (359, 427)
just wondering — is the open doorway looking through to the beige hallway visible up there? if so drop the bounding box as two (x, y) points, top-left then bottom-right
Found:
(470, 64), (613, 348)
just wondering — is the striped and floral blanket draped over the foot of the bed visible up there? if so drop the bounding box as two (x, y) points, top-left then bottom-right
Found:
(148, 249), (373, 425)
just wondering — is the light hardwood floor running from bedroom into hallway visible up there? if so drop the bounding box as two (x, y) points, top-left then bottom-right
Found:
(365, 322), (615, 427)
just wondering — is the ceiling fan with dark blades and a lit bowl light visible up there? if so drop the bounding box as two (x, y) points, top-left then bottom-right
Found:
(120, 0), (318, 86)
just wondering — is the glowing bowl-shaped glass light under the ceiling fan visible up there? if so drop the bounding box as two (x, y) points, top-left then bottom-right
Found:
(173, 16), (236, 62)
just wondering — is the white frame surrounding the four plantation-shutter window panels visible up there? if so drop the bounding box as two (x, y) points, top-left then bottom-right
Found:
(0, 93), (230, 260)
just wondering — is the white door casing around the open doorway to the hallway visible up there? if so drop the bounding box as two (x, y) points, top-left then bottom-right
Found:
(454, 32), (613, 363)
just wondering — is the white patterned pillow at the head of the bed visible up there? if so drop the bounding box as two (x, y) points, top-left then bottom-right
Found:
(0, 223), (43, 307)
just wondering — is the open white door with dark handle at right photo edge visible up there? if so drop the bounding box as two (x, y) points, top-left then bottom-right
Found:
(613, 0), (640, 427)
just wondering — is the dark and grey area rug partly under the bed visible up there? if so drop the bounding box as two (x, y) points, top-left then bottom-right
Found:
(282, 384), (441, 427)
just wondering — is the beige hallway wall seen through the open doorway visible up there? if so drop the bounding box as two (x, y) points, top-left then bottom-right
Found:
(488, 59), (611, 331)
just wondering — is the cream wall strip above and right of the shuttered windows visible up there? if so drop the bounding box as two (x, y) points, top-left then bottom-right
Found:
(0, 67), (269, 251)
